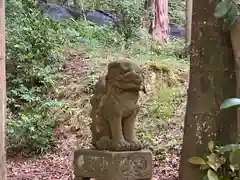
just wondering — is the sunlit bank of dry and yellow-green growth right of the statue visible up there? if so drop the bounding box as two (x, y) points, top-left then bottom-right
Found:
(137, 64), (188, 152)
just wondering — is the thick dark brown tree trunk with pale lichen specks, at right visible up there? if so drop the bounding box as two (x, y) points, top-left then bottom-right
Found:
(179, 0), (237, 180)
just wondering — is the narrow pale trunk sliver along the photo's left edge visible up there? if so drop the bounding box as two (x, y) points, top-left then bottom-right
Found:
(0, 0), (7, 180)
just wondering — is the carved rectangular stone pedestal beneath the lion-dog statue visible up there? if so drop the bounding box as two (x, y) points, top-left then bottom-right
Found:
(74, 149), (152, 180)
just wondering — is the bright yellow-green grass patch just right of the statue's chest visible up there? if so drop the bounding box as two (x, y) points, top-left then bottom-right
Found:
(138, 87), (182, 134)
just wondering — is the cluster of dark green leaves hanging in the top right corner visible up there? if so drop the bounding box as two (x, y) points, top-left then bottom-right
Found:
(215, 0), (240, 29)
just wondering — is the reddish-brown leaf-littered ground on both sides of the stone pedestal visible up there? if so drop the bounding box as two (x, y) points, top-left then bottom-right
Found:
(7, 52), (186, 180)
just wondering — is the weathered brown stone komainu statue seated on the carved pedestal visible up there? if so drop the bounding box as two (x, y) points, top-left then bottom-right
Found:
(90, 60), (143, 151)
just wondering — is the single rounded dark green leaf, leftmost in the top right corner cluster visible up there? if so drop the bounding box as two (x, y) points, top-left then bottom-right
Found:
(215, 0), (232, 18)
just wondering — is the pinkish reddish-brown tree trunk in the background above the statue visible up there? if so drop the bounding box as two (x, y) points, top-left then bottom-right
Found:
(151, 0), (169, 44)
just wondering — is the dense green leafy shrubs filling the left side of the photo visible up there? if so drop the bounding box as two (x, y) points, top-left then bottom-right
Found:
(6, 1), (66, 153)
